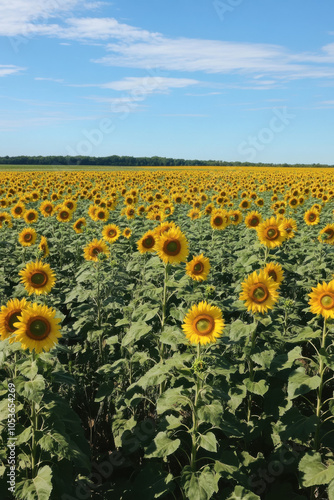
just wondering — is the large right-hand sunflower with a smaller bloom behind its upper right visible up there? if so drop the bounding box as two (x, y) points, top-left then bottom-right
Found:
(240, 269), (279, 314)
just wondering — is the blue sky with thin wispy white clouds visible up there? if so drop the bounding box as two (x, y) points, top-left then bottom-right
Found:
(0, 0), (334, 164)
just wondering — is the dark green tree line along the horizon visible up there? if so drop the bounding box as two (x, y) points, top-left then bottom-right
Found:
(0, 155), (334, 168)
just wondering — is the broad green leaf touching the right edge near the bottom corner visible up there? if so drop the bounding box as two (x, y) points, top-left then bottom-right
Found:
(299, 452), (334, 488)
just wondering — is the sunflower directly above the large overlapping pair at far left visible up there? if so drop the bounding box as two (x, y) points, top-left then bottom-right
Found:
(19, 261), (56, 295)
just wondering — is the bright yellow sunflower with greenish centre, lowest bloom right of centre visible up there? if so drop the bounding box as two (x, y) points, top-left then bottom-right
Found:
(182, 301), (225, 344)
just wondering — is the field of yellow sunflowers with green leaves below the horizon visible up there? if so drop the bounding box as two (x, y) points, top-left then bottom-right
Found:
(0, 167), (334, 500)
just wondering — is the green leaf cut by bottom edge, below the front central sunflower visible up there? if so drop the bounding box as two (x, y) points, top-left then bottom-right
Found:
(182, 466), (220, 500)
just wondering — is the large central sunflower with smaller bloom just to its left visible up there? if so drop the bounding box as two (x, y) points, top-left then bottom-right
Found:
(155, 228), (189, 264)
